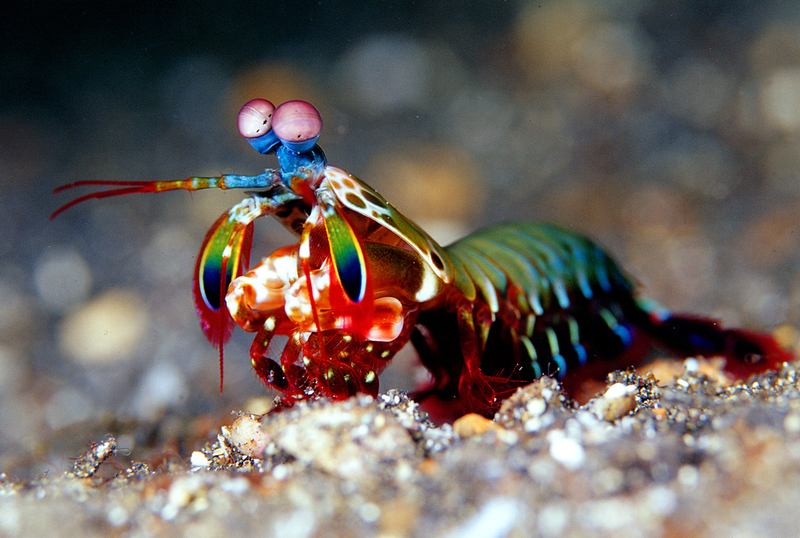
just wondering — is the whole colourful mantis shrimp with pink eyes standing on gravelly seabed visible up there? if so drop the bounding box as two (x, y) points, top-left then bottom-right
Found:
(51, 99), (792, 414)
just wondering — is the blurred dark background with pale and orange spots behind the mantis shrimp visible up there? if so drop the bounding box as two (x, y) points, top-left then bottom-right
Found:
(0, 0), (800, 477)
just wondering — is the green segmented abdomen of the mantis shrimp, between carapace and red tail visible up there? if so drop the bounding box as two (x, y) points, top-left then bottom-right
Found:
(412, 223), (641, 396)
